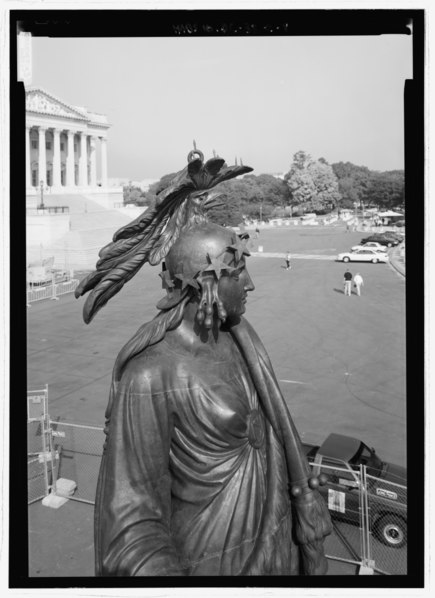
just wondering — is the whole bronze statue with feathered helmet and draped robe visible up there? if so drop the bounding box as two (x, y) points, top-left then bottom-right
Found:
(77, 148), (331, 576)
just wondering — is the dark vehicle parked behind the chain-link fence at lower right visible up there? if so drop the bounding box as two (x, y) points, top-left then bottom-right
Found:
(302, 434), (407, 548)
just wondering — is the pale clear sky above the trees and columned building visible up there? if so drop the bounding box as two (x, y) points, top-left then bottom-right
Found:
(32, 35), (412, 181)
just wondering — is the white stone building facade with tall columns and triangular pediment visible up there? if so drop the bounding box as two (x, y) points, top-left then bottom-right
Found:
(26, 88), (110, 194)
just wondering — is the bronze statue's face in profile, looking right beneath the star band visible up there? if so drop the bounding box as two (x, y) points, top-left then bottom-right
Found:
(218, 259), (255, 322)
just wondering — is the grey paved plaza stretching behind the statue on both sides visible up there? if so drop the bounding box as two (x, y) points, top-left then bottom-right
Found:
(28, 227), (406, 576)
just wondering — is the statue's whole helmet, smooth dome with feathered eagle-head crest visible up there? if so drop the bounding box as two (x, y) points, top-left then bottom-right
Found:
(74, 142), (252, 324)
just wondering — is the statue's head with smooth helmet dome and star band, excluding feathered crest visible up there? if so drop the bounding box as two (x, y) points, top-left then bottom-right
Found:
(157, 222), (254, 328)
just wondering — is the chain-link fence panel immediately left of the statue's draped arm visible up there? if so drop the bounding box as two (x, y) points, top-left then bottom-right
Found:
(50, 420), (104, 504)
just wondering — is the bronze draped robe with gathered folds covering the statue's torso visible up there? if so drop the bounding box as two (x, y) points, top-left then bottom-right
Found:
(95, 319), (324, 576)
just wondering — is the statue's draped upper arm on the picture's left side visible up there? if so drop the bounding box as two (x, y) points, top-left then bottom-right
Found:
(97, 372), (185, 576)
